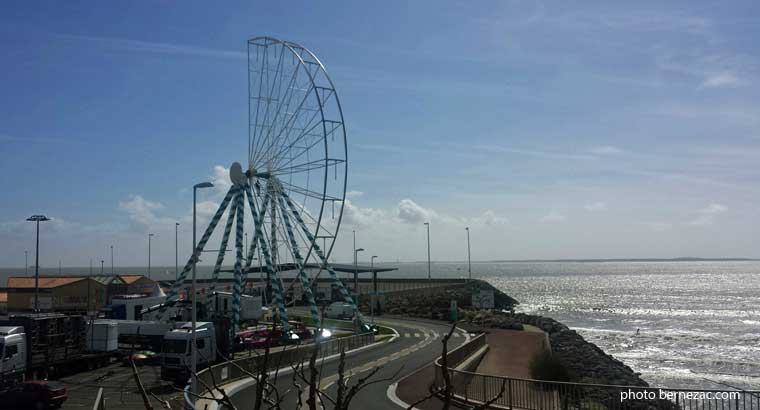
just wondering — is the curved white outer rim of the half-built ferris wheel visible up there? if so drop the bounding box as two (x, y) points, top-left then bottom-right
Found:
(247, 36), (348, 262)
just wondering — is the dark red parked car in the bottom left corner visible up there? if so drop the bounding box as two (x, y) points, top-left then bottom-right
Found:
(0, 380), (68, 410)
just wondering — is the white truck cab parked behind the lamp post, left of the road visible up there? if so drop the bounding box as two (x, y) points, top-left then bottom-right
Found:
(161, 322), (217, 382)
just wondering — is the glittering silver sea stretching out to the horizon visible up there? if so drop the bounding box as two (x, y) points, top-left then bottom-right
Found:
(0, 261), (760, 390)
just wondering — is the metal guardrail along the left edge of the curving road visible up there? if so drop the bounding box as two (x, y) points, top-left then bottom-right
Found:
(198, 333), (375, 394)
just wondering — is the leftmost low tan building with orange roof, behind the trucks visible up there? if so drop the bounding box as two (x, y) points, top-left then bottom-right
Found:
(8, 276), (107, 313)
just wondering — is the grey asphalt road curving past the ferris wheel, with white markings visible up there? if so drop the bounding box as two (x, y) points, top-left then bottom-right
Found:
(223, 318), (466, 410)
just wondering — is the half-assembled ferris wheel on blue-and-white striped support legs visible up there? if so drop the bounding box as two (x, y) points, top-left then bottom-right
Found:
(162, 37), (365, 330)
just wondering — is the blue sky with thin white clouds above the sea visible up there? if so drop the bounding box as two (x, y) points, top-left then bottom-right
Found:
(0, 1), (760, 267)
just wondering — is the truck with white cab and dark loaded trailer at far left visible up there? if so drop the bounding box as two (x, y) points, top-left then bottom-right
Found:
(0, 313), (118, 387)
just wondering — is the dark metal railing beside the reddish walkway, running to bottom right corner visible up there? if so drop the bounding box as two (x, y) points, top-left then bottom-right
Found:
(435, 334), (760, 410)
